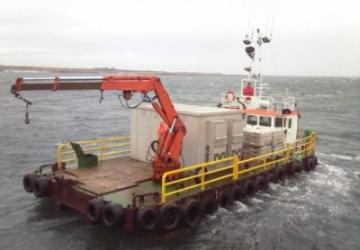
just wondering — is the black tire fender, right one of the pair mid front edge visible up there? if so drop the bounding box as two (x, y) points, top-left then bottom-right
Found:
(101, 203), (125, 227)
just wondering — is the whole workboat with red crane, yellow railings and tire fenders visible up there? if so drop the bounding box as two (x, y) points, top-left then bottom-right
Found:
(11, 31), (317, 234)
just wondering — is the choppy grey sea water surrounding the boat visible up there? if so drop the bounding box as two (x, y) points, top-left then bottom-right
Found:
(0, 72), (360, 250)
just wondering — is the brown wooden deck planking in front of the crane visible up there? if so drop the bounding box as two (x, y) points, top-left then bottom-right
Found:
(63, 156), (153, 195)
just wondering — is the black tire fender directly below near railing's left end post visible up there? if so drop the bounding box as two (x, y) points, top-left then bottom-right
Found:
(160, 203), (183, 231)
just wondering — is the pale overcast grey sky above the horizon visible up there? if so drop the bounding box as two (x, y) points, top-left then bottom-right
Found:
(0, 0), (360, 76)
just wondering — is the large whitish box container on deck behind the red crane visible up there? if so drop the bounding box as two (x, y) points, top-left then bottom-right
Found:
(130, 104), (244, 166)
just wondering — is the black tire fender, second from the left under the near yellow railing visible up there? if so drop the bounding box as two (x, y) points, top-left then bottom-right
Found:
(183, 199), (203, 228)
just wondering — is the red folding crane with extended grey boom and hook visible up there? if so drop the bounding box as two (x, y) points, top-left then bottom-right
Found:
(11, 75), (186, 181)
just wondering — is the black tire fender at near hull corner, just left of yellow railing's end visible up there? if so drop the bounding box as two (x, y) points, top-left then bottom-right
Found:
(136, 207), (159, 231)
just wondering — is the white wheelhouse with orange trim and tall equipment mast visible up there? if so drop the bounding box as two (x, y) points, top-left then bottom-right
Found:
(217, 29), (310, 151)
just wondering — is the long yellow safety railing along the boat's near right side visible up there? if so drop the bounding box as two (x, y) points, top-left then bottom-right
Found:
(161, 132), (316, 203)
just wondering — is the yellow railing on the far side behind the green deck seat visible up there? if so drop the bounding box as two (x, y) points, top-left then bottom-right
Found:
(56, 136), (130, 166)
